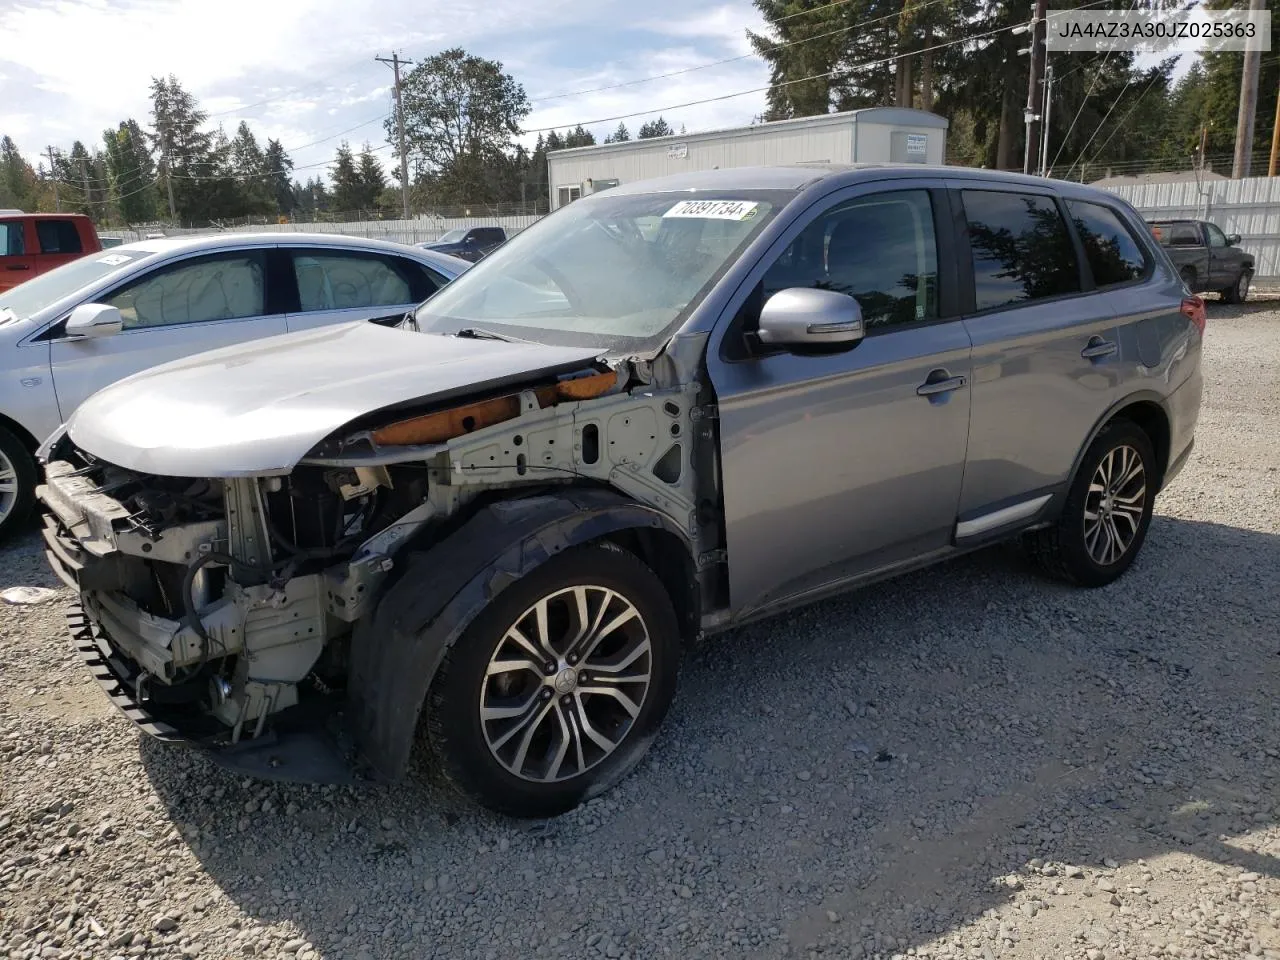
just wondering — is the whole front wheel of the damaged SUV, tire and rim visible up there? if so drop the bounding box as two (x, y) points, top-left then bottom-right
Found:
(426, 544), (681, 817)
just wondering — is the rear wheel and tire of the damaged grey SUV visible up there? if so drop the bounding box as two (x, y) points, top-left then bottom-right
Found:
(1024, 420), (1157, 586)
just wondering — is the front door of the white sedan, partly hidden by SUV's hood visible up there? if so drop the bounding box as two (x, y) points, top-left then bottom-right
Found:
(51, 250), (285, 421)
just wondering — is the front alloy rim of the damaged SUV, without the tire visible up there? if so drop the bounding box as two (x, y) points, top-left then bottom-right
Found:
(479, 585), (653, 783)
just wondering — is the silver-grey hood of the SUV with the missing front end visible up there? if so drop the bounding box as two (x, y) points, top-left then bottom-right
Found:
(67, 321), (600, 476)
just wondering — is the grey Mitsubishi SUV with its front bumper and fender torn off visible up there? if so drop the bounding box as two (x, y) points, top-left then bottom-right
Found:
(40, 165), (1204, 815)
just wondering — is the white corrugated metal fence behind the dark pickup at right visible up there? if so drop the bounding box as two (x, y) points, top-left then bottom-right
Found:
(1106, 177), (1280, 283)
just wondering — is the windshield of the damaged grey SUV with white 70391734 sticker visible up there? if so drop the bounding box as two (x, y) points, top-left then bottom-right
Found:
(416, 191), (794, 351)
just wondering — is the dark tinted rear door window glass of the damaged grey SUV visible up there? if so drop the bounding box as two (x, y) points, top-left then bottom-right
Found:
(963, 189), (1080, 310)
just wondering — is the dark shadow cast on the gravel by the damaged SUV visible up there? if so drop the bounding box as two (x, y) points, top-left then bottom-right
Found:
(142, 517), (1280, 957)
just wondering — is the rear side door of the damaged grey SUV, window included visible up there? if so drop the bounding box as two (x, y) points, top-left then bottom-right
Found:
(951, 183), (1121, 541)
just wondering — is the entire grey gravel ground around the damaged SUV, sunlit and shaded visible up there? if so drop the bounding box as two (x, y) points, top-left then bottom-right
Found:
(0, 301), (1280, 960)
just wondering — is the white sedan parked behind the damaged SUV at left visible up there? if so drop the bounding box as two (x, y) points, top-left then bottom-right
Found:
(0, 233), (471, 538)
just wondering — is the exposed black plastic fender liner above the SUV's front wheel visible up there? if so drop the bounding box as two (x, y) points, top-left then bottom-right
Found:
(347, 488), (687, 781)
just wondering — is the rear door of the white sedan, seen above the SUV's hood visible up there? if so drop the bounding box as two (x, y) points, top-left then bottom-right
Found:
(283, 246), (445, 330)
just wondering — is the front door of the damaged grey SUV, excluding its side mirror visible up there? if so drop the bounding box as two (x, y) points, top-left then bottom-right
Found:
(708, 182), (970, 616)
